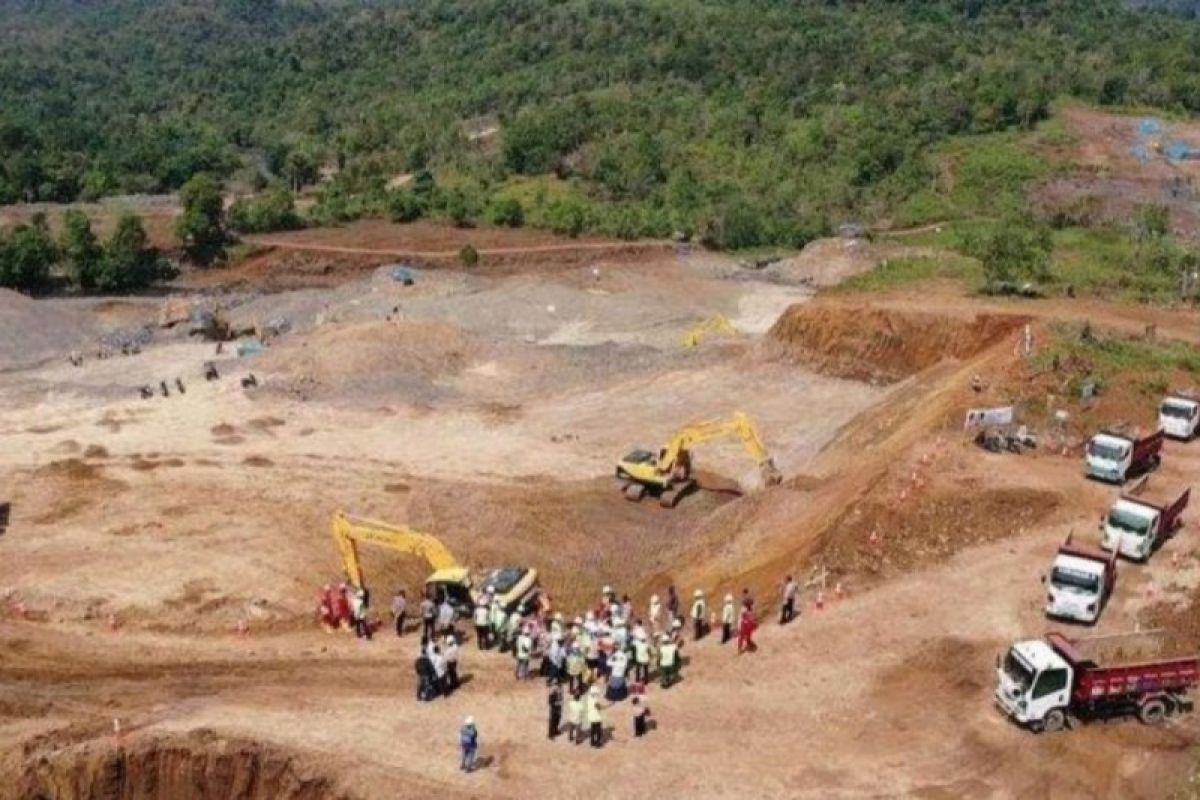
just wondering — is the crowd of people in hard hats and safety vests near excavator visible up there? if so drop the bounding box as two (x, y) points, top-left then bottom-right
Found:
(319, 576), (799, 771)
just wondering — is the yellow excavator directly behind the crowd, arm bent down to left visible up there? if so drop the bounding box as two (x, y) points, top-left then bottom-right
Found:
(334, 511), (539, 609)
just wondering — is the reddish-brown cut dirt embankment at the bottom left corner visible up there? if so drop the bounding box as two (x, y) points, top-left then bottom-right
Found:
(15, 732), (350, 800)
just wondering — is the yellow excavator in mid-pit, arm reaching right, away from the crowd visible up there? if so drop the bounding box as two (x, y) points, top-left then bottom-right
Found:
(617, 411), (782, 509)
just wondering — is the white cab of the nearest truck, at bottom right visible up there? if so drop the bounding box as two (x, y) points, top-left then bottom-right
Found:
(995, 639), (1074, 730)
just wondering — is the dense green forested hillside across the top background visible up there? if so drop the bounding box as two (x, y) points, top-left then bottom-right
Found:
(0, 0), (1200, 246)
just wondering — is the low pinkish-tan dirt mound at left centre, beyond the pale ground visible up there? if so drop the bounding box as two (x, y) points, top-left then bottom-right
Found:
(260, 321), (482, 403)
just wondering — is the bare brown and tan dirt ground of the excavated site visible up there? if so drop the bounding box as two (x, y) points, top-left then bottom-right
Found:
(0, 225), (1200, 800)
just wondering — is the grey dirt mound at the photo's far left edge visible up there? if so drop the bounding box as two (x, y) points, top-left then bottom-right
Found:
(0, 289), (95, 369)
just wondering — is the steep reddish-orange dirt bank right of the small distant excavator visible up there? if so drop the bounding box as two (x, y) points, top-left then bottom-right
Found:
(763, 303), (1026, 383)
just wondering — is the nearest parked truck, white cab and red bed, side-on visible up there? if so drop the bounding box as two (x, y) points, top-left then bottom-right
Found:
(995, 631), (1200, 733)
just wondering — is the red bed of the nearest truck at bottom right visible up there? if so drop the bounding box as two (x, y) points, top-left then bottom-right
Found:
(1046, 633), (1200, 704)
